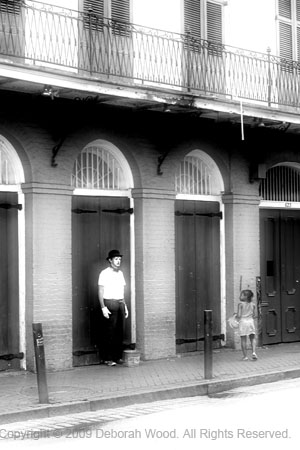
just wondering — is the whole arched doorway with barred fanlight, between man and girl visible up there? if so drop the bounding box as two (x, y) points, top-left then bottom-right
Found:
(175, 150), (225, 353)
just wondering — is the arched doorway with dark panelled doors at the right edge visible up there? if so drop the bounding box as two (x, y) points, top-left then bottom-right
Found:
(259, 163), (300, 344)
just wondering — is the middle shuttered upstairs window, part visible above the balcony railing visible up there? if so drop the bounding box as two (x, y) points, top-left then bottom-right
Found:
(184, 0), (223, 44)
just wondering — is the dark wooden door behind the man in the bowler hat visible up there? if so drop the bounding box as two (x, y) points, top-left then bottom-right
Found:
(72, 196), (132, 366)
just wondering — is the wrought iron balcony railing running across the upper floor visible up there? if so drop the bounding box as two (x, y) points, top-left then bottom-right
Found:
(0, 0), (300, 108)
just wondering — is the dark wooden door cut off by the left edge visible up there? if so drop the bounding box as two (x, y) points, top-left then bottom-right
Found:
(0, 192), (20, 370)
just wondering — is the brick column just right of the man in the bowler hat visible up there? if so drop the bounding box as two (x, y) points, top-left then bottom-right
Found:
(132, 188), (176, 359)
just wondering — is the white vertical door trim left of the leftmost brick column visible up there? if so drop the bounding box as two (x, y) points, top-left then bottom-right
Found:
(18, 190), (26, 370)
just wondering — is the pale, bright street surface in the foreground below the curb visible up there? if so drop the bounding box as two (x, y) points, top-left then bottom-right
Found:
(1, 379), (300, 450)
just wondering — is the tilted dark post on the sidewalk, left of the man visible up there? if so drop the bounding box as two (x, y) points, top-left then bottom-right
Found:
(32, 323), (49, 403)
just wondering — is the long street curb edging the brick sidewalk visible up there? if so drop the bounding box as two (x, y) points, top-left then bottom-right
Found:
(0, 368), (300, 425)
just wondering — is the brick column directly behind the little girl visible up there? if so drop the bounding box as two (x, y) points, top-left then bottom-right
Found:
(223, 194), (260, 348)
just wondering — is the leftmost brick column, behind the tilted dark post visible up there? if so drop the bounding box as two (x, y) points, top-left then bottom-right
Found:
(22, 183), (72, 370)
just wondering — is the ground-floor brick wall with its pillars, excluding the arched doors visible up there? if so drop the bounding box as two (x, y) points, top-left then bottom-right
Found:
(1, 95), (270, 369)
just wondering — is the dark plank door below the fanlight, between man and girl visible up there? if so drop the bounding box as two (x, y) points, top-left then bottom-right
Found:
(175, 201), (221, 352)
